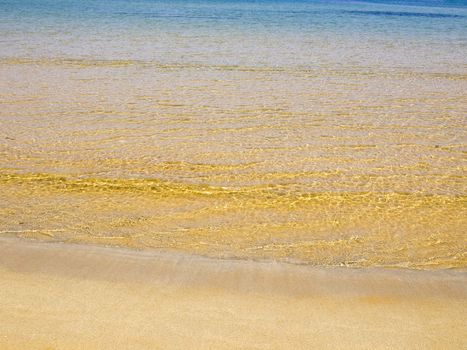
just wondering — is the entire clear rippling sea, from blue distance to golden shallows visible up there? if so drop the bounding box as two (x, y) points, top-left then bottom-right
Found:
(0, 0), (467, 269)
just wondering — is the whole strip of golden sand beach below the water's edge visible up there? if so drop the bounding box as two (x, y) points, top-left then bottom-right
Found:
(0, 238), (467, 349)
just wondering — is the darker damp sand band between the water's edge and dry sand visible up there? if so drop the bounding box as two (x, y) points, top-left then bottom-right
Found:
(0, 237), (467, 298)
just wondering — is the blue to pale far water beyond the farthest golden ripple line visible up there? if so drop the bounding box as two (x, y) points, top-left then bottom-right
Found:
(0, 0), (467, 71)
